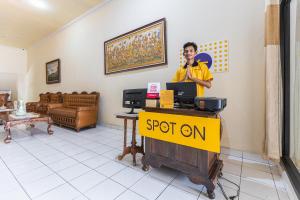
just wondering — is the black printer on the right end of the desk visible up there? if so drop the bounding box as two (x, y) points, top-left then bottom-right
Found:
(195, 97), (227, 112)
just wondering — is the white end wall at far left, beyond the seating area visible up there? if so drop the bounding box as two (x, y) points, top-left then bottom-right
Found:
(0, 45), (27, 99)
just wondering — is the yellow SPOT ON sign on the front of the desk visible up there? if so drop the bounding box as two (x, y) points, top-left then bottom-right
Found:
(139, 112), (220, 153)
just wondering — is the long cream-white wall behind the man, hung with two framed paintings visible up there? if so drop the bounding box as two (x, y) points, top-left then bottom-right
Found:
(28, 0), (265, 152)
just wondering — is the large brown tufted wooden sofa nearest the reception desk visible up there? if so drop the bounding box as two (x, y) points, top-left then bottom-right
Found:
(48, 92), (99, 132)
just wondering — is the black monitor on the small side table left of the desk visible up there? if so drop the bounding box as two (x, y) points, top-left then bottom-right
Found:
(123, 88), (147, 114)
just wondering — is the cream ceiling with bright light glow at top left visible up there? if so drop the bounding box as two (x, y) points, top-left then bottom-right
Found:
(0, 0), (104, 48)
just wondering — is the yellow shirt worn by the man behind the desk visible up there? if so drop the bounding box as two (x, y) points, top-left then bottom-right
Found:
(172, 61), (213, 97)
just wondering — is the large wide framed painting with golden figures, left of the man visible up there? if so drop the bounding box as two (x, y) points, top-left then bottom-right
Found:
(104, 18), (167, 74)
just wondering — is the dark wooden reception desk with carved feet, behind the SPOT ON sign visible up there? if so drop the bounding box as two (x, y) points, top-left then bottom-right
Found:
(142, 108), (223, 199)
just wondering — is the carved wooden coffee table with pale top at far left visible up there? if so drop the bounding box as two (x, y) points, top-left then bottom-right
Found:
(0, 114), (53, 144)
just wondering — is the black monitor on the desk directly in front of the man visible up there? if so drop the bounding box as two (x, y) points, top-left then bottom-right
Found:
(167, 82), (197, 107)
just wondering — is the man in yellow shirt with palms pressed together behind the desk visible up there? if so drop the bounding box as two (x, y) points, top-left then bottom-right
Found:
(172, 42), (213, 97)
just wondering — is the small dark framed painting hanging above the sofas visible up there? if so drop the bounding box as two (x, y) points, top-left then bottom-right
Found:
(46, 59), (60, 84)
